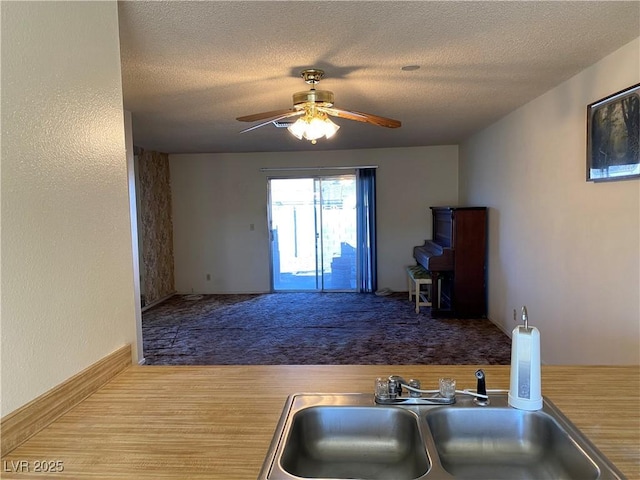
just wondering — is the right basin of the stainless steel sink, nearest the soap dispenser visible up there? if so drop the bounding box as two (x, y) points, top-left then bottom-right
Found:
(426, 407), (600, 480)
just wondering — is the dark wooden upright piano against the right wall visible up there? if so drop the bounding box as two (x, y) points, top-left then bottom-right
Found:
(413, 207), (487, 318)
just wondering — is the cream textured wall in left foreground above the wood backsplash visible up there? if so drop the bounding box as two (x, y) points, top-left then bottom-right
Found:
(1, 1), (136, 415)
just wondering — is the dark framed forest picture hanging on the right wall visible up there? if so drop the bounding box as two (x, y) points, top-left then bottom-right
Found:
(587, 83), (640, 182)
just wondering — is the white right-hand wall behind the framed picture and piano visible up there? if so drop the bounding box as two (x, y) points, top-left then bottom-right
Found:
(460, 39), (640, 364)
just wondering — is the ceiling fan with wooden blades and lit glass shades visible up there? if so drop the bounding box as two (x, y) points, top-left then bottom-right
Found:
(236, 68), (402, 144)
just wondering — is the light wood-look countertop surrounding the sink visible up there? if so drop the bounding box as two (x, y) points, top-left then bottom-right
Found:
(0, 365), (640, 480)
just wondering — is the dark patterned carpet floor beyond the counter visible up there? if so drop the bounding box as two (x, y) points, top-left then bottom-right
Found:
(142, 293), (511, 365)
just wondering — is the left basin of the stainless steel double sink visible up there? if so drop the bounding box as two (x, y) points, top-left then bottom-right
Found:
(281, 406), (429, 480)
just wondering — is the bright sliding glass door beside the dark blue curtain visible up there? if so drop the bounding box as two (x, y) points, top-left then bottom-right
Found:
(269, 175), (358, 291)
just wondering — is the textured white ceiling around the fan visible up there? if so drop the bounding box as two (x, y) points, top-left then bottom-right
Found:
(119, 0), (640, 153)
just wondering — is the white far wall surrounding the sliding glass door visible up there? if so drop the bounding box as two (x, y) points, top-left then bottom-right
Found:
(169, 146), (458, 293)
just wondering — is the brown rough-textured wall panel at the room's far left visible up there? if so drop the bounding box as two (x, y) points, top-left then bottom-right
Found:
(138, 152), (175, 305)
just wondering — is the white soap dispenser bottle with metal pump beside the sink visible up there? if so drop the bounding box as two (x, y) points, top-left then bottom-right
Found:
(509, 307), (542, 410)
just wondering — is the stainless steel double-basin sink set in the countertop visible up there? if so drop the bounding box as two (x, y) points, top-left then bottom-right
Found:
(258, 394), (625, 480)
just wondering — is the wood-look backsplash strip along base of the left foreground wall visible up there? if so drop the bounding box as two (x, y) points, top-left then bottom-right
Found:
(0, 345), (132, 456)
